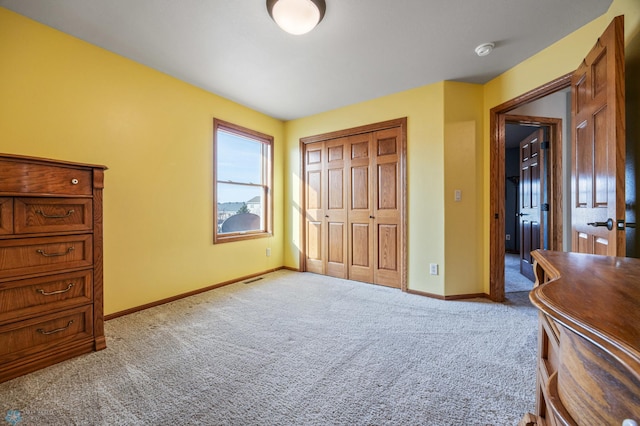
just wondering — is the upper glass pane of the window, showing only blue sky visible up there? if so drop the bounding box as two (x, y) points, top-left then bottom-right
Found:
(216, 130), (263, 184)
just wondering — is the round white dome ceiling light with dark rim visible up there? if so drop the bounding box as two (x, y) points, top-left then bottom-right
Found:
(267, 0), (327, 35)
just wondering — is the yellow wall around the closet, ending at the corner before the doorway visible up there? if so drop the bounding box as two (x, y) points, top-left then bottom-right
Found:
(285, 82), (483, 295)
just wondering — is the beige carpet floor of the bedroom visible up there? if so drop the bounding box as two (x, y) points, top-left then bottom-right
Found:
(0, 271), (537, 426)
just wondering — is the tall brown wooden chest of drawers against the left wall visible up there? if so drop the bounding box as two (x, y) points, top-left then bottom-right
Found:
(0, 154), (106, 382)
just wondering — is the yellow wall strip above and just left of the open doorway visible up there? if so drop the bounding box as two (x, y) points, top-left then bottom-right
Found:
(482, 0), (640, 293)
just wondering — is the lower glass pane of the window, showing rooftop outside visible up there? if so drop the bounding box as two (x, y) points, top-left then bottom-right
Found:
(217, 183), (264, 234)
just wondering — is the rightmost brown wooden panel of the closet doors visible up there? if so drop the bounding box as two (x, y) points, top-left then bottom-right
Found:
(371, 127), (402, 288)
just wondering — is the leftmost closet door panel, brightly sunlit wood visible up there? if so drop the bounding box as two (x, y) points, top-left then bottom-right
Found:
(304, 142), (326, 274)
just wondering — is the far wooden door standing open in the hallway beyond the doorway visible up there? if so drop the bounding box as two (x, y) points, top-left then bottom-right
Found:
(518, 129), (544, 281)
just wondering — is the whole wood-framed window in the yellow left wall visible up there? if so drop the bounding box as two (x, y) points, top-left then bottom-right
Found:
(213, 119), (273, 244)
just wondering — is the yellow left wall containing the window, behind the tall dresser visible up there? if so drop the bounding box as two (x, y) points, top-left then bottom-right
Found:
(0, 8), (284, 314)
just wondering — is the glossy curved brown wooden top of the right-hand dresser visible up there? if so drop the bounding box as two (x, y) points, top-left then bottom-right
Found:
(529, 250), (640, 378)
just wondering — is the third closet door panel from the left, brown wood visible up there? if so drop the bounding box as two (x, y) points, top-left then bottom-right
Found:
(347, 133), (375, 283)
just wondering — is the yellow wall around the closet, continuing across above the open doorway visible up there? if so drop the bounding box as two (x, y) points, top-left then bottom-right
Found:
(284, 0), (640, 296)
